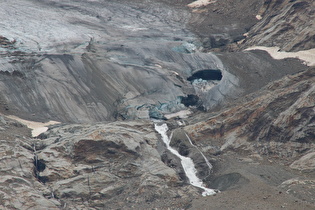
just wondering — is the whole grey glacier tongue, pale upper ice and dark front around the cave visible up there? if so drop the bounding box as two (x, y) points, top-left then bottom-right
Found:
(0, 0), (237, 123)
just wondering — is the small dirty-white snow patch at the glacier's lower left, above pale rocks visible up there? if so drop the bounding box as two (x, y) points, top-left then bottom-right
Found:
(6, 115), (60, 137)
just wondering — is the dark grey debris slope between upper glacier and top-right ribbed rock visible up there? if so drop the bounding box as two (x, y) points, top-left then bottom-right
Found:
(189, 0), (262, 51)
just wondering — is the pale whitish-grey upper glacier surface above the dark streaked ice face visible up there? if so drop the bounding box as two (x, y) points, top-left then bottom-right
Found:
(0, 0), (191, 53)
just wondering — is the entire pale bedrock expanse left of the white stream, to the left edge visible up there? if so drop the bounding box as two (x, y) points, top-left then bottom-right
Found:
(0, 119), (200, 209)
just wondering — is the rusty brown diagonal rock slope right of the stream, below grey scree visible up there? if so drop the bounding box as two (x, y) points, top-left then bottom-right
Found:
(186, 69), (315, 166)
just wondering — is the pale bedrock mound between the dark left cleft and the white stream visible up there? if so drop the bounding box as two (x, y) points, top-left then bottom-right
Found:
(37, 122), (202, 209)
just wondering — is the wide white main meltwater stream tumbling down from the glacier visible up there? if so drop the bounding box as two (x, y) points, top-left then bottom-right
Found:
(155, 124), (216, 196)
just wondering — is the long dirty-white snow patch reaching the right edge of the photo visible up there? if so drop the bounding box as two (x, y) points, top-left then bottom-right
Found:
(246, 46), (315, 66)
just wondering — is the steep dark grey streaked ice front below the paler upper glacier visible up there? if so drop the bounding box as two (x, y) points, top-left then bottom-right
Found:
(1, 47), (237, 122)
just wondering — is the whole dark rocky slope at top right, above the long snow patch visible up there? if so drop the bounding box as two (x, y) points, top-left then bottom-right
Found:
(190, 0), (315, 51)
